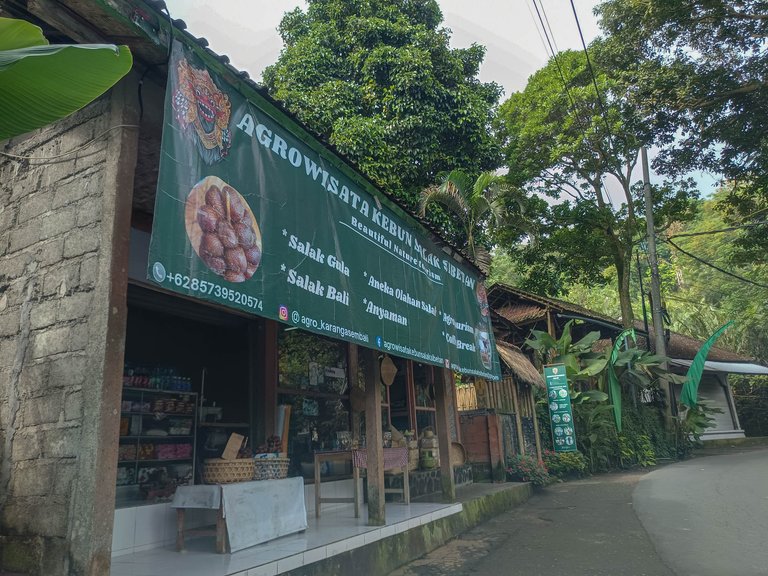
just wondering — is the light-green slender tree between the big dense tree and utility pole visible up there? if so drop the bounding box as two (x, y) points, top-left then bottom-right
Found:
(498, 51), (693, 326)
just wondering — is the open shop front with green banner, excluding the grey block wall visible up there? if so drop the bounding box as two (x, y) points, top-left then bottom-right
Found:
(113, 29), (499, 556)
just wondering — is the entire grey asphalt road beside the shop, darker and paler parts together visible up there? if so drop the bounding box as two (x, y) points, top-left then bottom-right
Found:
(390, 449), (768, 576)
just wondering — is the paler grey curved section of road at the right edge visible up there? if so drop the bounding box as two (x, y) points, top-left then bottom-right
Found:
(634, 448), (768, 576)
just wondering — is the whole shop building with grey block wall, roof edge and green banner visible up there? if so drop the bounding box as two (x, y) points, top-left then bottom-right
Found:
(0, 1), (499, 574)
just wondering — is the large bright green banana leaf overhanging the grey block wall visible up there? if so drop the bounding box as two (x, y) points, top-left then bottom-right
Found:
(0, 18), (133, 140)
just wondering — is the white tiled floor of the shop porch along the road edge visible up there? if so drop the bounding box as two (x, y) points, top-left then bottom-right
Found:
(111, 502), (461, 576)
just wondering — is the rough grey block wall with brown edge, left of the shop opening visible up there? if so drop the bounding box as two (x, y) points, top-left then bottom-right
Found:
(0, 79), (136, 575)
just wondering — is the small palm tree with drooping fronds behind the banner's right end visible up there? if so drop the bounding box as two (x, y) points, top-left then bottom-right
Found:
(420, 170), (513, 272)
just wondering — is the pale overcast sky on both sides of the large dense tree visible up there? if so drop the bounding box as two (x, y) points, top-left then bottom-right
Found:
(166, 0), (598, 96)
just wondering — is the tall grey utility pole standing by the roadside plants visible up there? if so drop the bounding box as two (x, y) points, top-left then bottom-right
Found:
(640, 146), (673, 431)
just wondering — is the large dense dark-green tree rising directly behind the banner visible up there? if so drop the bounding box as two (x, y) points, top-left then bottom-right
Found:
(264, 0), (501, 210)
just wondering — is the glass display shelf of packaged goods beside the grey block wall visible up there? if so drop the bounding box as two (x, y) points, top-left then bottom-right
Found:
(117, 386), (198, 506)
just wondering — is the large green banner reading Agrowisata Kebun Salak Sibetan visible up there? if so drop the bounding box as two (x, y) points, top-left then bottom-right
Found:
(148, 42), (499, 379)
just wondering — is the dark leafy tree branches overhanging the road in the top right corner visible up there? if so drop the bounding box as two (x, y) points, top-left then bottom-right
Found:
(597, 0), (768, 259)
